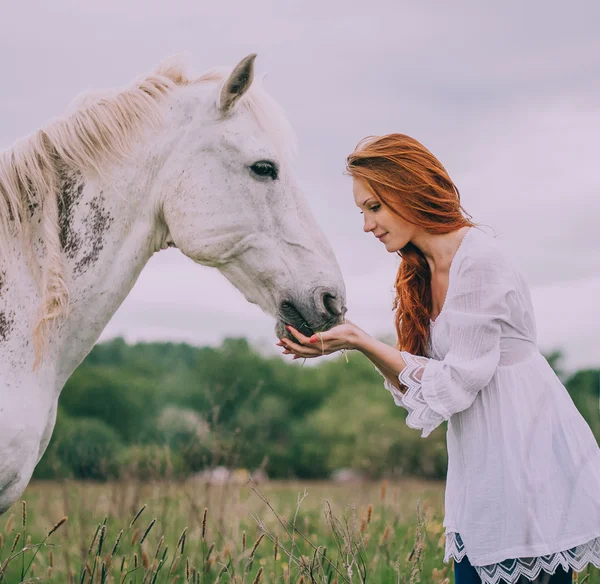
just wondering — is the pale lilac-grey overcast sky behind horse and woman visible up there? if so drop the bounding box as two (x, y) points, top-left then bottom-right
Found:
(0, 0), (600, 369)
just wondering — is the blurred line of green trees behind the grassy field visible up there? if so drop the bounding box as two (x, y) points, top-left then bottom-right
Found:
(34, 338), (600, 480)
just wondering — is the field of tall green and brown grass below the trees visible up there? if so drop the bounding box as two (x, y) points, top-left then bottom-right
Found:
(0, 480), (600, 584)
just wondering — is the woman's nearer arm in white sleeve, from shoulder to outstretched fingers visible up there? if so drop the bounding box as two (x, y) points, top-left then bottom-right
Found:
(283, 255), (514, 438)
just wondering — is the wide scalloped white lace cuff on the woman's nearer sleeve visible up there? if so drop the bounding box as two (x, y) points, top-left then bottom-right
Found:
(394, 351), (444, 438)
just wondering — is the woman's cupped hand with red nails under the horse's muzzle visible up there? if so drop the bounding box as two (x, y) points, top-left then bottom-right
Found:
(277, 320), (367, 359)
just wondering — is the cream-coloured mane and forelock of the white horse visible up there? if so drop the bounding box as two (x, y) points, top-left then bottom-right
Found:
(0, 61), (295, 367)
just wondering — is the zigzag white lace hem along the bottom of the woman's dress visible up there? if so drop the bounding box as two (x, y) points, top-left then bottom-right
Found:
(444, 532), (600, 584)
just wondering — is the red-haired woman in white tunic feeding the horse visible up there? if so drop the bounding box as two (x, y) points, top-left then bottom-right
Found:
(278, 134), (600, 584)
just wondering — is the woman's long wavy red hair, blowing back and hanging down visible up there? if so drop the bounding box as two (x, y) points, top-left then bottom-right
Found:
(346, 134), (475, 355)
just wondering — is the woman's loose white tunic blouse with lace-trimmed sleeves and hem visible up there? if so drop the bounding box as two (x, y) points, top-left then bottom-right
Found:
(385, 227), (600, 584)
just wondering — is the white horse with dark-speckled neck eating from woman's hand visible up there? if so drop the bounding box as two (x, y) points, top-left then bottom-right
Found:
(0, 55), (346, 514)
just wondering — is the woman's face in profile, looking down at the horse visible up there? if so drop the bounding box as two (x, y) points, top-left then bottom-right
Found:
(352, 178), (418, 253)
